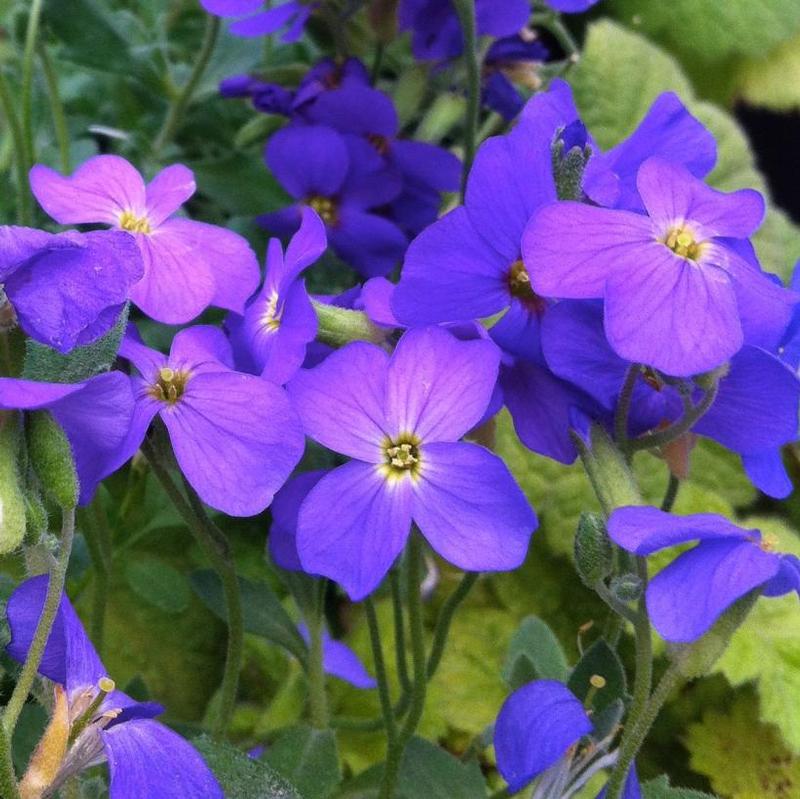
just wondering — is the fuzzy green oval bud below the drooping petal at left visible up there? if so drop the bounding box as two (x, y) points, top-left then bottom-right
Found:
(26, 411), (78, 508)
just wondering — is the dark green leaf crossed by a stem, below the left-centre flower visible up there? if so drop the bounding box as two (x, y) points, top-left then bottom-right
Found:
(191, 570), (308, 663)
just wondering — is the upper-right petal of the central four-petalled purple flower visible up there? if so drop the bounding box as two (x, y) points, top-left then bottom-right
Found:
(386, 327), (500, 443)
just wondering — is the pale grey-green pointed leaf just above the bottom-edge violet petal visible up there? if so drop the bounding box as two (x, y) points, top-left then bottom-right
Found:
(503, 616), (569, 689)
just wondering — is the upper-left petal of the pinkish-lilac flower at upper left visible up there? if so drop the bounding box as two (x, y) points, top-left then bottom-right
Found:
(30, 155), (146, 225)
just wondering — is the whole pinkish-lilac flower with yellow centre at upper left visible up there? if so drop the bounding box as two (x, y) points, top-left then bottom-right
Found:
(30, 155), (258, 324)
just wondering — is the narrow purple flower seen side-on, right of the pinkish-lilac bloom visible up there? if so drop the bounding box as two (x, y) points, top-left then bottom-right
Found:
(226, 208), (327, 385)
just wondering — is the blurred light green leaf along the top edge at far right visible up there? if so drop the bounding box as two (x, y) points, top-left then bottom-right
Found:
(613, 0), (800, 61)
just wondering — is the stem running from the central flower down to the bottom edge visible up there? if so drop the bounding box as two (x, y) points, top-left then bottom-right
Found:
(378, 533), (428, 799)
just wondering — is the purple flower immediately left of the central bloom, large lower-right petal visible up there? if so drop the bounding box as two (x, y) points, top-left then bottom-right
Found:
(111, 325), (303, 516)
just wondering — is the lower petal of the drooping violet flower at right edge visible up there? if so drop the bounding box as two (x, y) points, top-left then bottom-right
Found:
(646, 540), (780, 642)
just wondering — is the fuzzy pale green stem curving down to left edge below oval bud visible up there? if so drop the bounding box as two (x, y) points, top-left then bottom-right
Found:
(3, 508), (75, 738)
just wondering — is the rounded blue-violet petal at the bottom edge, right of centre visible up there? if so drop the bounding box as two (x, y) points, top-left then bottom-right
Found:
(494, 680), (592, 794)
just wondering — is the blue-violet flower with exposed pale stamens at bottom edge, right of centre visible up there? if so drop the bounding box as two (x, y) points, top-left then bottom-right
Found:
(494, 680), (641, 799)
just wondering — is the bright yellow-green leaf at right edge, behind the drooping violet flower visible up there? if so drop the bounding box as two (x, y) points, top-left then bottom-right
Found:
(716, 517), (800, 754)
